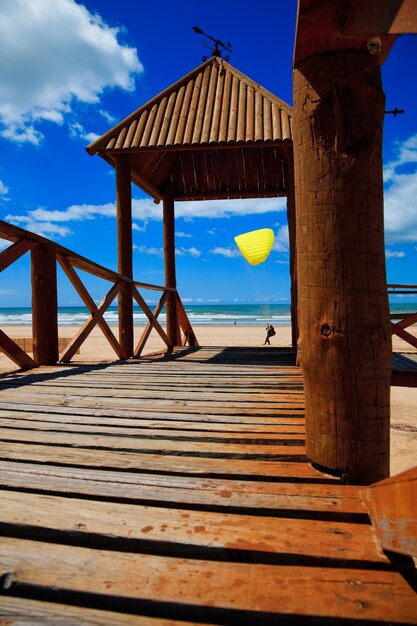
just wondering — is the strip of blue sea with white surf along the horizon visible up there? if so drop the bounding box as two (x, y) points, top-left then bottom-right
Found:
(0, 302), (417, 326)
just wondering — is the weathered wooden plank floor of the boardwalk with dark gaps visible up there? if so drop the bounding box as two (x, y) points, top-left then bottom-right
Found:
(0, 348), (417, 626)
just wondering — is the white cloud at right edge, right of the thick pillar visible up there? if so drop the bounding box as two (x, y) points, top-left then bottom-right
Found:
(384, 134), (417, 244)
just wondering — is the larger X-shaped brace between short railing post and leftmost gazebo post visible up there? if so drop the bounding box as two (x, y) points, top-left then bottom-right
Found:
(57, 254), (126, 362)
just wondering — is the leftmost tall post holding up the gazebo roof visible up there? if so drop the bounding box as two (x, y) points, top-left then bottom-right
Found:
(116, 154), (133, 358)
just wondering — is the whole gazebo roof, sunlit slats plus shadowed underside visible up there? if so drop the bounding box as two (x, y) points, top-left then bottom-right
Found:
(87, 57), (292, 200)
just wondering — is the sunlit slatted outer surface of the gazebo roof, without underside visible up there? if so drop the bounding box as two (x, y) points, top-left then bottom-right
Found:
(87, 58), (291, 154)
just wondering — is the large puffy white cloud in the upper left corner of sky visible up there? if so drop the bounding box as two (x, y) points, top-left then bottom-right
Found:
(0, 0), (143, 144)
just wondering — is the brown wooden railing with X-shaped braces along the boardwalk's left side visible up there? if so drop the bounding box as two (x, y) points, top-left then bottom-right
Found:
(0, 220), (198, 369)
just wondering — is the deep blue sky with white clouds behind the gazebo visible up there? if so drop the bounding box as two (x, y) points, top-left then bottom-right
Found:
(0, 0), (417, 307)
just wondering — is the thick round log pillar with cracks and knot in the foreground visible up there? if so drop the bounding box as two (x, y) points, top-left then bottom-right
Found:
(293, 51), (391, 484)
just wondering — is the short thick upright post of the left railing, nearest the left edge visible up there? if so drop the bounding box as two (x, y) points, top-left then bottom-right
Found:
(30, 243), (59, 365)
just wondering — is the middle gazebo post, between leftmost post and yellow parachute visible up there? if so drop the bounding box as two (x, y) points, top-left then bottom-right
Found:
(163, 186), (179, 348)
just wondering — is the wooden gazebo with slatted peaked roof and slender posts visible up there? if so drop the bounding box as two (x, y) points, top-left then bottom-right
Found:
(87, 56), (297, 355)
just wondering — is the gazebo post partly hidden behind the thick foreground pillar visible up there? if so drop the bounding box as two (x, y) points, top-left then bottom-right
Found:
(285, 156), (298, 350)
